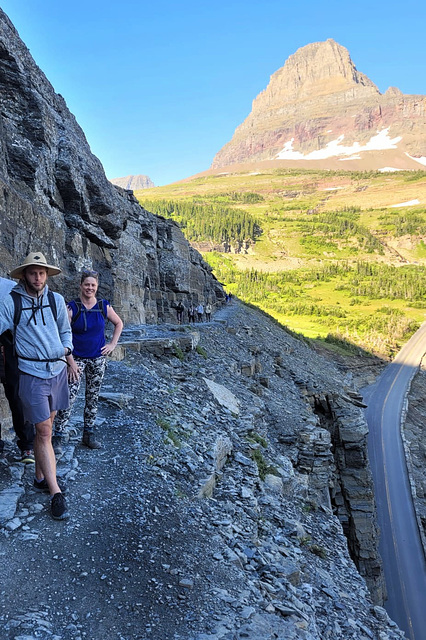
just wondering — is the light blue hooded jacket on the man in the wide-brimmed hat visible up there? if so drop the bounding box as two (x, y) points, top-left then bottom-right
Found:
(0, 282), (72, 378)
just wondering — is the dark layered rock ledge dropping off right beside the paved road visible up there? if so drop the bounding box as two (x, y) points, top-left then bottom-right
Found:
(252, 356), (386, 602)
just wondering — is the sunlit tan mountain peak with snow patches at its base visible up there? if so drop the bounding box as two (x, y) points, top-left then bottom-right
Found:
(212, 40), (426, 169)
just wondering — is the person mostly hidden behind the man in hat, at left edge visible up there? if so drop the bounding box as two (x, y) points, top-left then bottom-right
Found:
(0, 278), (34, 463)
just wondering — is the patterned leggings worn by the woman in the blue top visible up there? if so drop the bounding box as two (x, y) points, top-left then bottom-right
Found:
(53, 356), (107, 435)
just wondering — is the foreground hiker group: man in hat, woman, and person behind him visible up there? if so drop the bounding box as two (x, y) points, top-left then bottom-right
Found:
(0, 252), (123, 520)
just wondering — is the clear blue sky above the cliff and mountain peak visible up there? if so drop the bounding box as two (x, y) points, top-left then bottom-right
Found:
(0, 0), (426, 185)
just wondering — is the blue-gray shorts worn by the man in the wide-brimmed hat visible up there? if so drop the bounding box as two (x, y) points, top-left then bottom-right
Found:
(19, 367), (69, 424)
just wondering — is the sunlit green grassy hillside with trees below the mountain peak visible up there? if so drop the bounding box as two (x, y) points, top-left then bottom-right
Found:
(135, 170), (426, 356)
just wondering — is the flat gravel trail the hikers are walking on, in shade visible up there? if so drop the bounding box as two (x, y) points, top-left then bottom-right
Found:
(0, 362), (220, 640)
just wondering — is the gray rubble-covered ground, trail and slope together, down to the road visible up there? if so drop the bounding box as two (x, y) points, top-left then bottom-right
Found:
(0, 301), (404, 640)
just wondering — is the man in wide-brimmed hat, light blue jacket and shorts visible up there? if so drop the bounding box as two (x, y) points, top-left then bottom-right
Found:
(0, 252), (72, 520)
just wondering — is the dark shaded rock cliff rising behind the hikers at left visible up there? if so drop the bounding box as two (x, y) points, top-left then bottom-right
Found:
(0, 10), (223, 323)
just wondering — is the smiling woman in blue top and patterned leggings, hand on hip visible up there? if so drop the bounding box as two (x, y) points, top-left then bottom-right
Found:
(53, 270), (123, 454)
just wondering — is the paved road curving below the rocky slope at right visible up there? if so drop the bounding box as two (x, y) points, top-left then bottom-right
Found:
(364, 323), (426, 640)
